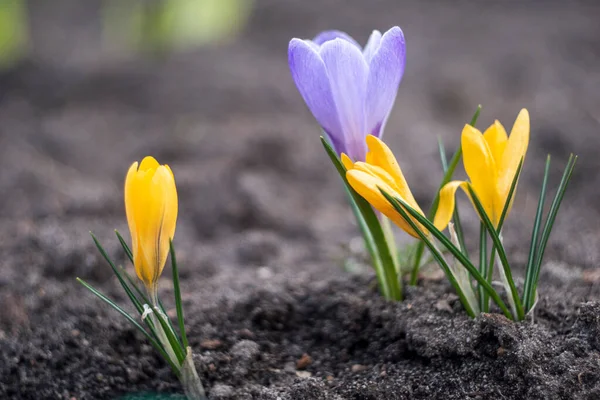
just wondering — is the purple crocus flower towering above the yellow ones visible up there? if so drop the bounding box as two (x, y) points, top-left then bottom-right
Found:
(288, 26), (406, 161)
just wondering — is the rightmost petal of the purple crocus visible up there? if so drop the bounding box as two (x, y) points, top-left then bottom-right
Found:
(365, 26), (406, 137)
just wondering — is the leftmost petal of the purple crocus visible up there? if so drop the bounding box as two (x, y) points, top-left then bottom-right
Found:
(288, 39), (343, 145)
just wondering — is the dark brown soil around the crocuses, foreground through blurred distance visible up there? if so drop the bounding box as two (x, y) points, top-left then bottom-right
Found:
(0, 0), (600, 400)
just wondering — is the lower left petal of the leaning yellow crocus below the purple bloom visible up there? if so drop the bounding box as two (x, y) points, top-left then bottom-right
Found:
(346, 169), (422, 238)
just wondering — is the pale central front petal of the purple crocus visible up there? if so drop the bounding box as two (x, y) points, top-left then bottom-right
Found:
(320, 38), (369, 161)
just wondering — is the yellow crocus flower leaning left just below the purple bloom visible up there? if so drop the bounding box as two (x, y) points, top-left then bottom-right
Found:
(342, 135), (448, 238)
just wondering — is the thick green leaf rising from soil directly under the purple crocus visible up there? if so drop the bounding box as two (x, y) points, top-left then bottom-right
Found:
(321, 136), (402, 300)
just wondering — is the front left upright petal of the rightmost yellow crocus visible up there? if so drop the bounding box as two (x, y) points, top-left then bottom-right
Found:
(461, 125), (504, 225)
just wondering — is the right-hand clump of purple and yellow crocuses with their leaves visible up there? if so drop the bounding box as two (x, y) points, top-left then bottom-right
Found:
(288, 27), (576, 320)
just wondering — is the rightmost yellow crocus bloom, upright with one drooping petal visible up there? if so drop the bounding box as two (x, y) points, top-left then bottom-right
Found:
(435, 109), (529, 226)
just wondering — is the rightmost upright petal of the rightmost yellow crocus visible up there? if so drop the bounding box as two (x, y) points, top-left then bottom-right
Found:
(498, 109), (529, 205)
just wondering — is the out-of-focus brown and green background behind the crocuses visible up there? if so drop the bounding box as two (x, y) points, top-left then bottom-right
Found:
(0, 0), (600, 396)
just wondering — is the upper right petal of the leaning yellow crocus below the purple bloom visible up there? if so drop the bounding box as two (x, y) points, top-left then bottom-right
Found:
(366, 135), (423, 214)
